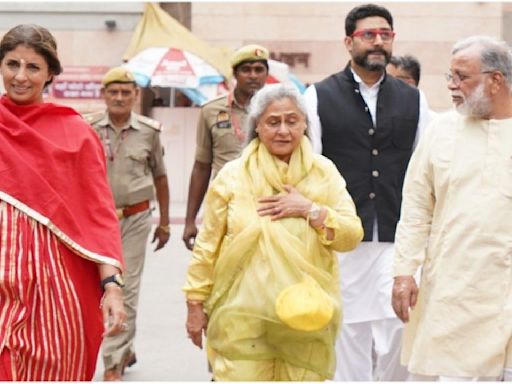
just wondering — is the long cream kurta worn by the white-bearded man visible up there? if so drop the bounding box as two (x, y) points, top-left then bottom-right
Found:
(394, 112), (512, 376)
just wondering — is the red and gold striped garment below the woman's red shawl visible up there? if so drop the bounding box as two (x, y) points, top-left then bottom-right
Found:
(0, 201), (102, 381)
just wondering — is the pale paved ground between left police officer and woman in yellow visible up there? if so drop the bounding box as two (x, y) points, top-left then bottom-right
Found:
(94, 205), (210, 381)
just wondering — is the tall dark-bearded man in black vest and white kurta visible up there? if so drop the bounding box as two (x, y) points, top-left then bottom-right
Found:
(306, 4), (428, 381)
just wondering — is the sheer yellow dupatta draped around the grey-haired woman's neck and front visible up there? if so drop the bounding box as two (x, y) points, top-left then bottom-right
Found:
(205, 138), (340, 377)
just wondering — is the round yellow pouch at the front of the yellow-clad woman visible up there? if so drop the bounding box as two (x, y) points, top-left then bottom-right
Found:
(276, 276), (334, 332)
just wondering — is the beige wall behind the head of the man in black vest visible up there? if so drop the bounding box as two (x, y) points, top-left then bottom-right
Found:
(192, 2), (504, 110)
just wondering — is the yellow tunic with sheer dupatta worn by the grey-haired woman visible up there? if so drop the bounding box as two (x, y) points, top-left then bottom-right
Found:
(185, 138), (363, 378)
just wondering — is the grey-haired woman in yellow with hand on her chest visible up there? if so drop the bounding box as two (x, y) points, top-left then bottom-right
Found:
(184, 84), (363, 381)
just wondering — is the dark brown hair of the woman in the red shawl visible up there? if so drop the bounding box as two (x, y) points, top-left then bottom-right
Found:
(0, 24), (62, 86)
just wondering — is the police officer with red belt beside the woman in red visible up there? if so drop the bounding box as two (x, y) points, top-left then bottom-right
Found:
(85, 67), (170, 381)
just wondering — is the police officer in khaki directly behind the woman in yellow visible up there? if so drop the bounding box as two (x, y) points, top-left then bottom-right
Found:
(183, 44), (269, 250)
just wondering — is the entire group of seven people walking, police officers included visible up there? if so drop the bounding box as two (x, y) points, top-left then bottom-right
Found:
(0, 4), (512, 381)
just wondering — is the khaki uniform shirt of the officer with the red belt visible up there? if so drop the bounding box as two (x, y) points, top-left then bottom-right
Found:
(85, 112), (166, 208)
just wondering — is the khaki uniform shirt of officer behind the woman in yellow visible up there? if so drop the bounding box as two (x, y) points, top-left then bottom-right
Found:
(195, 96), (247, 176)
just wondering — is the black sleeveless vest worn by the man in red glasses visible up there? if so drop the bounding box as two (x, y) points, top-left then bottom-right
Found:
(315, 65), (419, 242)
